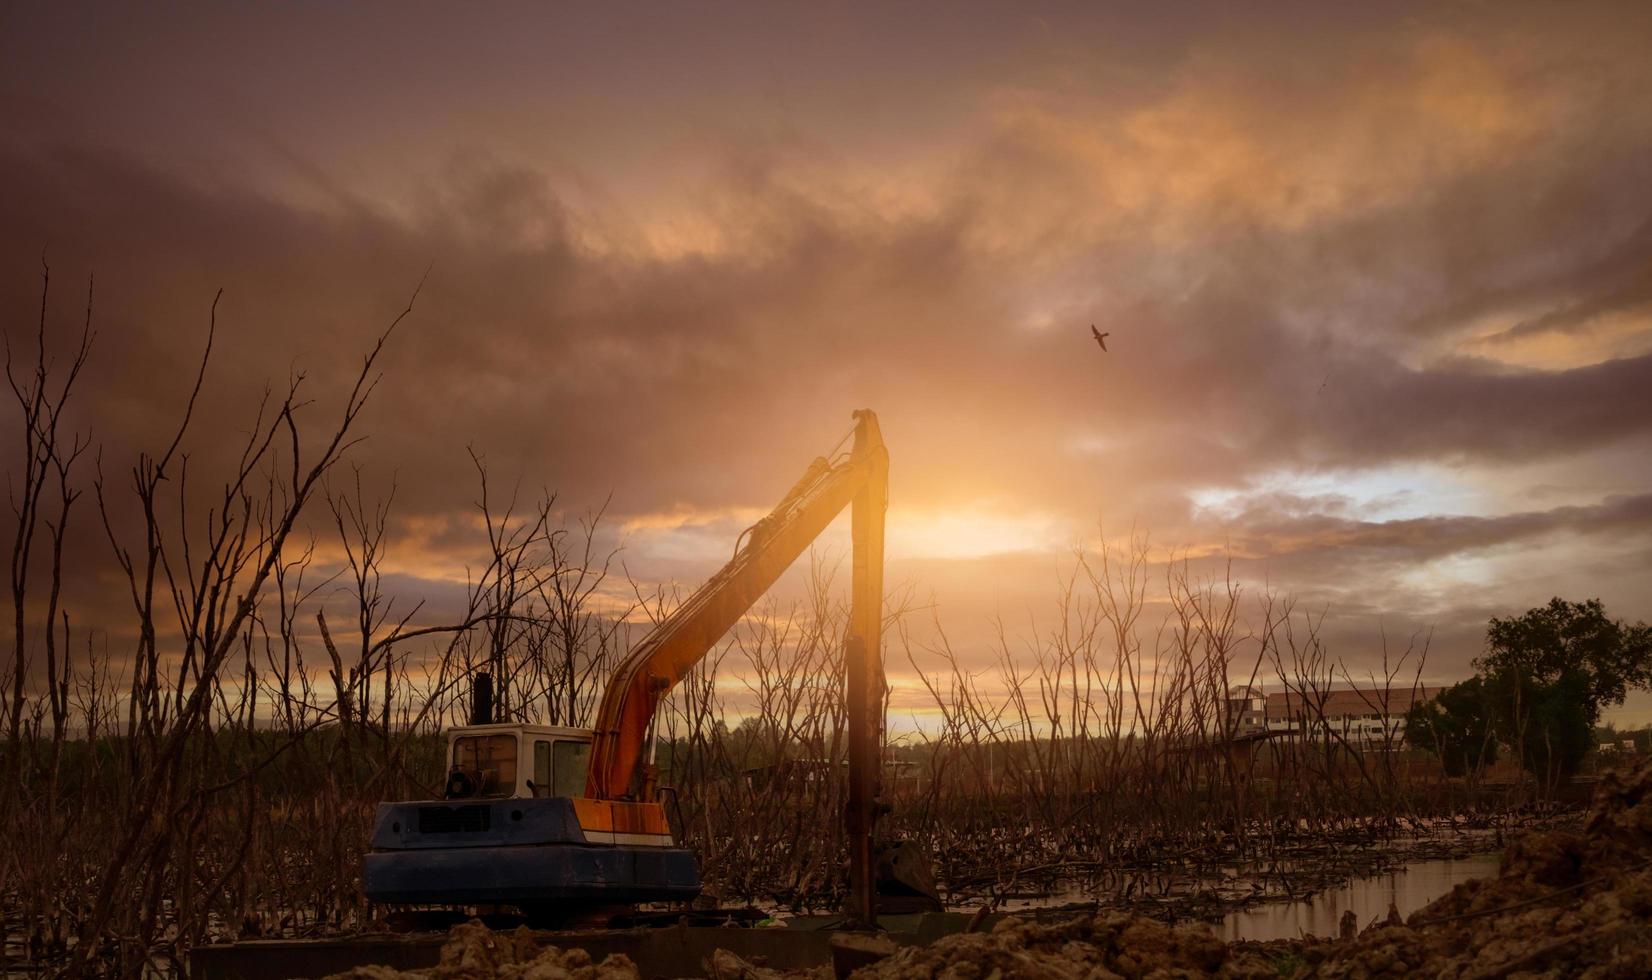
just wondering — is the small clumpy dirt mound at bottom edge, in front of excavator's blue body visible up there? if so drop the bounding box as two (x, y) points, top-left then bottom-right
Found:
(327, 919), (641, 980)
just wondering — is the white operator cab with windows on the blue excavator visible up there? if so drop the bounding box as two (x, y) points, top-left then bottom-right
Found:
(443, 722), (591, 800)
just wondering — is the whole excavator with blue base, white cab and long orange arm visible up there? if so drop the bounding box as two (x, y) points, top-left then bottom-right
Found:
(362, 410), (932, 924)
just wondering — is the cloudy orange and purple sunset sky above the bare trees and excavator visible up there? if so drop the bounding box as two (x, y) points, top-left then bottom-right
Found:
(0, 2), (1652, 722)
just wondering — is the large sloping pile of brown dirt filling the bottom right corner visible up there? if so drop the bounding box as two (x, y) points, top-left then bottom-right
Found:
(1298, 760), (1652, 980)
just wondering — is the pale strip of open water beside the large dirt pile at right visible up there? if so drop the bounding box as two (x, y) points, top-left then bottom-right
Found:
(1216, 854), (1497, 942)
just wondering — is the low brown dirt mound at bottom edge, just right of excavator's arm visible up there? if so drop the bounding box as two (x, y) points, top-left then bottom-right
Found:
(854, 912), (1279, 980)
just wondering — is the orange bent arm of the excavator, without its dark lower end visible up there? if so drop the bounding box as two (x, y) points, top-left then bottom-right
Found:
(585, 410), (889, 800)
